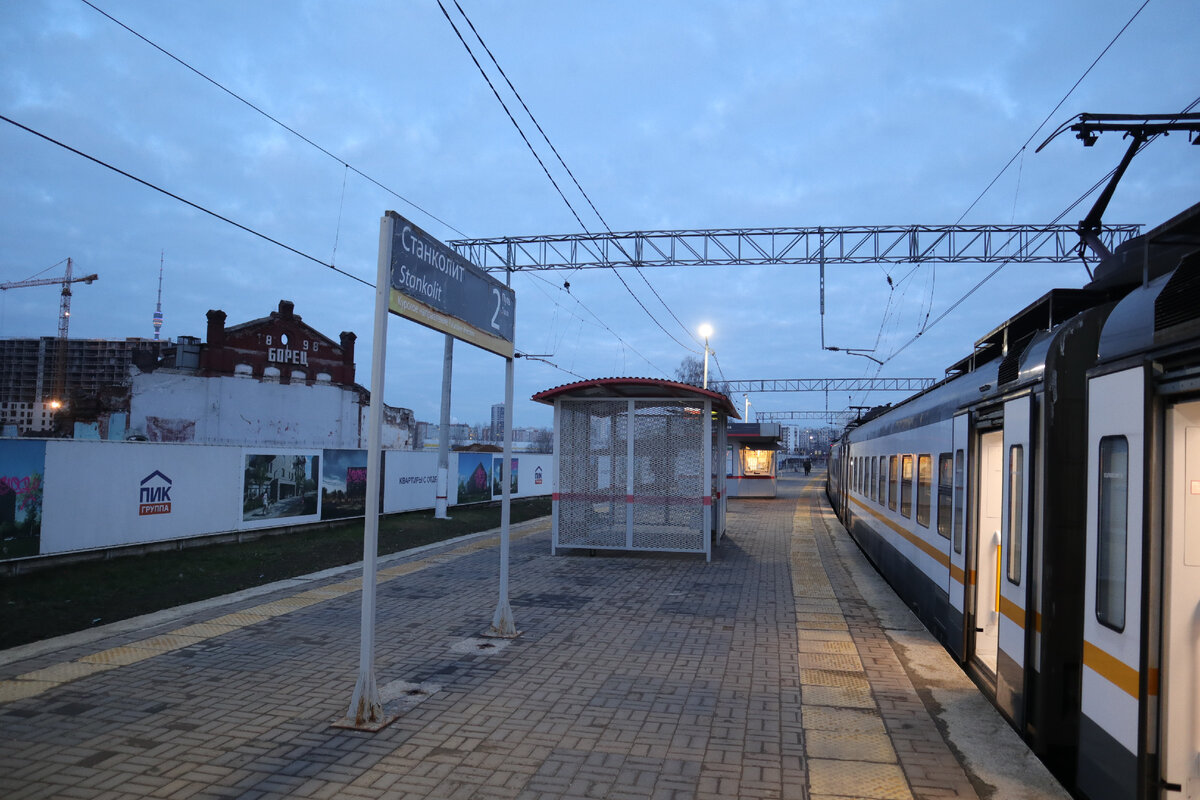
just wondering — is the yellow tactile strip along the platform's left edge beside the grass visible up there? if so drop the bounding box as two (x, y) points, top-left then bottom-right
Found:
(0, 523), (550, 703)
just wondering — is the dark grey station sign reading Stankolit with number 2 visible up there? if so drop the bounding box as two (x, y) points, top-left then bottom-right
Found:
(386, 211), (516, 359)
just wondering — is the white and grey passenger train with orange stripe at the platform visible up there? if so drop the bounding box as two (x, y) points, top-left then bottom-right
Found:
(827, 204), (1200, 800)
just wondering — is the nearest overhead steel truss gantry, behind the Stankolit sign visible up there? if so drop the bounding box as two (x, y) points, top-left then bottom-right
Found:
(449, 224), (1141, 271)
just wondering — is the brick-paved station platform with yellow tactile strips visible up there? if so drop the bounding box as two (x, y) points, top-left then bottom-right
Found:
(0, 475), (1070, 800)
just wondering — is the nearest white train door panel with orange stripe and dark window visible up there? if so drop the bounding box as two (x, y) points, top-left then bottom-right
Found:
(1076, 367), (1142, 800)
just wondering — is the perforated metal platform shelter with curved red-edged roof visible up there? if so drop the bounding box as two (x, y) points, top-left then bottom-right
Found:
(533, 378), (738, 560)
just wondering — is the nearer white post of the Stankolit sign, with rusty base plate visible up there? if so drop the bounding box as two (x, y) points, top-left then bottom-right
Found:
(346, 216), (392, 730)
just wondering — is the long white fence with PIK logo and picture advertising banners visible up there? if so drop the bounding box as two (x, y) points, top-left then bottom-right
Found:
(7, 439), (553, 560)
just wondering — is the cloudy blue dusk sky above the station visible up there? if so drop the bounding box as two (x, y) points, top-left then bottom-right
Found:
(0, 0), (1200, 426)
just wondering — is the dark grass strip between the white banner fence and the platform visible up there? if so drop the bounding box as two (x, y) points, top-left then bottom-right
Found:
(0, 498), (551, 650)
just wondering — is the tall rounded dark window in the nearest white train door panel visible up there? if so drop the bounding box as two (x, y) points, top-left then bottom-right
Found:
(1096, 437), (1129, 631)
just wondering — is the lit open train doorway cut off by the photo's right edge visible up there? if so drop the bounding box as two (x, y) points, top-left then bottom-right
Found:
(1159, 401), (1200, 800)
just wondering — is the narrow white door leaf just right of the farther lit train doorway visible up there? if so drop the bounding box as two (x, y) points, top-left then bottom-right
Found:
(996, 395), (1033, 730)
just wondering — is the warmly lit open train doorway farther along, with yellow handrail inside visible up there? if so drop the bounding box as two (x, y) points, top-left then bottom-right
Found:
(967, 431), (1004, 679)
